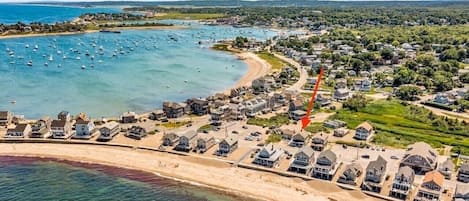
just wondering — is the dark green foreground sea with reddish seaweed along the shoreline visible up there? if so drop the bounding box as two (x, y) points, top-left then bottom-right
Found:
(0, 157), (252, 201)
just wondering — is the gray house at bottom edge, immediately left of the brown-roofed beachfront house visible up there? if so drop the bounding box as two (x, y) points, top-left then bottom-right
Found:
(389, 166), (415, 200)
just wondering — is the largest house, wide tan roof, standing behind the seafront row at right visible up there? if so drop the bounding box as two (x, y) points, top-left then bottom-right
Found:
(400, 142), (437, 174)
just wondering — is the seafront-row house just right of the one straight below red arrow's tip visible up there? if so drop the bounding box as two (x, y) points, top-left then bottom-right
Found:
(313, 150), (337, 180)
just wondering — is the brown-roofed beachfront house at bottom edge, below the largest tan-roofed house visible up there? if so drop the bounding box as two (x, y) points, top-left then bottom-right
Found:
(414, 170), (445, 201)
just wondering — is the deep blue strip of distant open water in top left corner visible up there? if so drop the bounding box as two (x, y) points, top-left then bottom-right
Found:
(0, 4), (121, 24)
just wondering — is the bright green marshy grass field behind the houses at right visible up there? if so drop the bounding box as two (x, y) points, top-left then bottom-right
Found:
(331, 100), (469, 154)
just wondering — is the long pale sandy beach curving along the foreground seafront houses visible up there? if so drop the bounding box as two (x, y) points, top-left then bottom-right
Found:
(0, 143), (375, 201)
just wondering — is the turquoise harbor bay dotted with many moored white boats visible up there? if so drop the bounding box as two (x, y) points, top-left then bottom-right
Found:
(0, 6), (276, 118)
